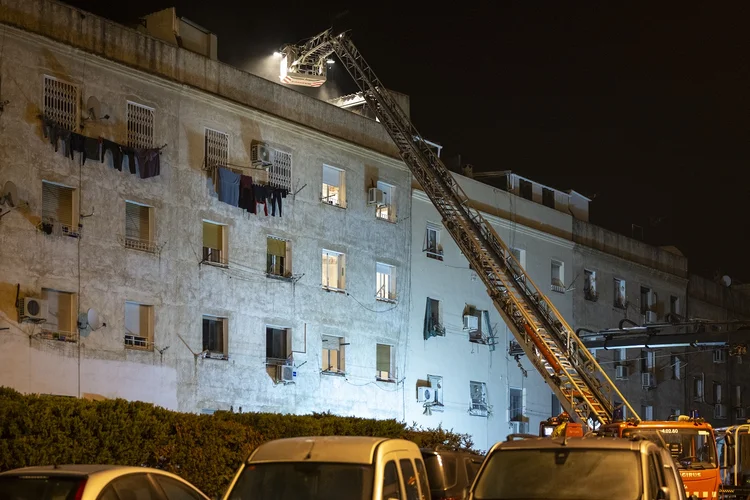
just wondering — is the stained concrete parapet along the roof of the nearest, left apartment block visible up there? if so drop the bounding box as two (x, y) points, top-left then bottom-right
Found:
(0, 0), (398, 157)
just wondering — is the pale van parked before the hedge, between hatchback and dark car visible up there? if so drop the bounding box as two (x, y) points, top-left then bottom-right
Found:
(224, 436), (430, 500)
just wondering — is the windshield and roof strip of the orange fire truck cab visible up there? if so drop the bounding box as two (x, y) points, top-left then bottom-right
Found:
(622, 427), (718, 469)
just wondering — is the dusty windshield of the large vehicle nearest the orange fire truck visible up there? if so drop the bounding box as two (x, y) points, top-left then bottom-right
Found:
(474, 447), (642, 500)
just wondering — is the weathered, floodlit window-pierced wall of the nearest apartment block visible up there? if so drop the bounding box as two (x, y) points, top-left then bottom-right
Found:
(0, 21), (411, 418)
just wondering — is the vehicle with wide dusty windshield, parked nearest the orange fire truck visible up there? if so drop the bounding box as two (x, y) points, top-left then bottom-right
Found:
(469, 436), (686, 500)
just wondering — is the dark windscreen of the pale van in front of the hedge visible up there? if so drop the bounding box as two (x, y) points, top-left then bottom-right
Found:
(229, 462), (374, 500)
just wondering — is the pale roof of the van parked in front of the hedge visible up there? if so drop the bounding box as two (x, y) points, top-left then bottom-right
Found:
(248, 436), (406, 464)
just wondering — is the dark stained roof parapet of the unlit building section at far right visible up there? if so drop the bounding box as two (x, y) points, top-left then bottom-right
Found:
(573, 220), (687, 278)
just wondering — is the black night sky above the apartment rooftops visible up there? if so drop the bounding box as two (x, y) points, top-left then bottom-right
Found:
(68, 0), (750, 282)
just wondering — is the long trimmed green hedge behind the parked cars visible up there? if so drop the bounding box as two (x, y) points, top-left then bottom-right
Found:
(0, 387), (473, 497)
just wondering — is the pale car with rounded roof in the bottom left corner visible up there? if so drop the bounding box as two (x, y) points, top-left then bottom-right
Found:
(0, 465), (209, 500)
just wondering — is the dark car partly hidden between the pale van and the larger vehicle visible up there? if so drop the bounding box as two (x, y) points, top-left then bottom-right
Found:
(420, 448), (484, 500)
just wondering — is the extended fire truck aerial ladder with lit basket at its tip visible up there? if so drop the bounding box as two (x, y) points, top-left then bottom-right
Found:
(280, 29), (637, 427)
